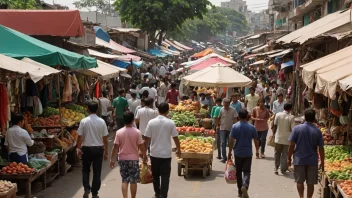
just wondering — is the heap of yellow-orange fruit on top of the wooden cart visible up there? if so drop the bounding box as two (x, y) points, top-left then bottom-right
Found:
(179, 135), (213, 153)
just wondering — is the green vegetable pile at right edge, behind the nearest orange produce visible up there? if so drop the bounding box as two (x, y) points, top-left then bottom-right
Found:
(324, 146), (352, 162)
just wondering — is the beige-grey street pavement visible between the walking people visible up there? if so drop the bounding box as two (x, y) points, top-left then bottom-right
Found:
(34, 130), (318, 198)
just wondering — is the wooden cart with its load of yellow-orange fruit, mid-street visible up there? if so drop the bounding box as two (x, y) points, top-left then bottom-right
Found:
(177, 135), (214, 178)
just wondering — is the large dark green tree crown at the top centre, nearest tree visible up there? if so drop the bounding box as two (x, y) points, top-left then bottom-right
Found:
(114, 0), (211, 44)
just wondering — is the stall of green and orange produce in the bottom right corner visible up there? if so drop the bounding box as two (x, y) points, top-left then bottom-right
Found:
(319, 145), (352, 198)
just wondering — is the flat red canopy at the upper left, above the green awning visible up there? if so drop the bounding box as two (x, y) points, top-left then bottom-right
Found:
(0, 9), (84, 37)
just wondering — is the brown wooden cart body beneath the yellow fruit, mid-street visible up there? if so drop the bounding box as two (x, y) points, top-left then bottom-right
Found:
(177, 152), (213, 178)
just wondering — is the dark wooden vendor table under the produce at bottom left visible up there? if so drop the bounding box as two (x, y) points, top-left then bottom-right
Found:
(0, 155), (59, 198)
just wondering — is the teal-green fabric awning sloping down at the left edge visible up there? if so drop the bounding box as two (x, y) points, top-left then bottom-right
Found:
(0, 25), (97, 69)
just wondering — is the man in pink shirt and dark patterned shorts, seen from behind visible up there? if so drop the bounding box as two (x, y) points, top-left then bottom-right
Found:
(110, 112), (148, 198)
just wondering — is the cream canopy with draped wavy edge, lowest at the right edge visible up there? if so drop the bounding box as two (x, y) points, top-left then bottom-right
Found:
(301, 43), (352, 99)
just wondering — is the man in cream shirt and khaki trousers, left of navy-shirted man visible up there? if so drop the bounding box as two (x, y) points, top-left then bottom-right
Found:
(273, 103), (295, 174)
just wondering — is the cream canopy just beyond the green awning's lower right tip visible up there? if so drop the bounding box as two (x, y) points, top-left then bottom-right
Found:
(77, 60), (127, 80)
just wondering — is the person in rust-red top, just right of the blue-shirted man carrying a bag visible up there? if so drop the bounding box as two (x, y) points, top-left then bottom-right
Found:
(252, 98), (270, 158)
